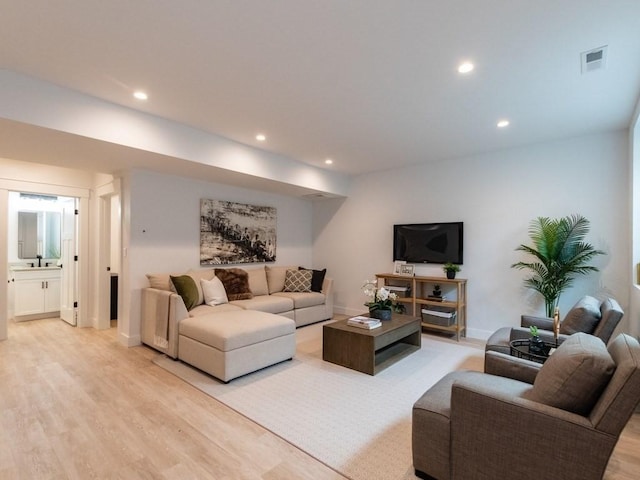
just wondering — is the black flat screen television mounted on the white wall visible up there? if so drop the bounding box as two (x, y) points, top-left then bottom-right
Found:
(393, 222), (463, 265)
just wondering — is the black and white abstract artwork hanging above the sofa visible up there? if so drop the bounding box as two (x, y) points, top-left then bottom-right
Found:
(200, 199), (277, 265)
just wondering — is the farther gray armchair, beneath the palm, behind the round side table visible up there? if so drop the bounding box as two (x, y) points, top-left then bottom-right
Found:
(485, 295), (624, 360)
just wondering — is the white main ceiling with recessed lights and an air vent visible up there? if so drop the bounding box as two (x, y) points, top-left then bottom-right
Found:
(0, 0), (640, 175)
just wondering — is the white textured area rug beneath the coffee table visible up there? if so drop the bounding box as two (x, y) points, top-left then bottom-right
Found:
(154, 318), (484, 480)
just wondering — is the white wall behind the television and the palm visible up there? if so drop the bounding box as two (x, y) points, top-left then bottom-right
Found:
(313, 131), (631, 338)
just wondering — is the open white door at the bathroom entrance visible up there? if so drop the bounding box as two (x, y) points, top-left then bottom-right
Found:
(60, 198), (78, 326)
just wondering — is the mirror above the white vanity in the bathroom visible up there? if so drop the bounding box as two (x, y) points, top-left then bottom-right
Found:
(18, 212), (61, 259)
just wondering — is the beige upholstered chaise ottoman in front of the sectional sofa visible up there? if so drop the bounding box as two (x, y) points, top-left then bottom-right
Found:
(178, 310), (296, 382)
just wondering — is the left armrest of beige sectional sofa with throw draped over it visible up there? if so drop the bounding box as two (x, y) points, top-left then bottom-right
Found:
(141, 288), (189, 358)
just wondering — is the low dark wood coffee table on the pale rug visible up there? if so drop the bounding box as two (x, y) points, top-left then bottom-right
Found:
(322, 313), (422, 375)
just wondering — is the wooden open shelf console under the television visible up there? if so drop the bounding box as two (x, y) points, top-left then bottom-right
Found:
(376, 273), (467, 341)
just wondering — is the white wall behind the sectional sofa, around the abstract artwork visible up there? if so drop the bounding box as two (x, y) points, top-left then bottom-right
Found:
(118, 170), (312, 345)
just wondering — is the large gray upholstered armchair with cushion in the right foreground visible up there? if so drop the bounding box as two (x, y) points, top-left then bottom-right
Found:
(412, 333), (640, 480)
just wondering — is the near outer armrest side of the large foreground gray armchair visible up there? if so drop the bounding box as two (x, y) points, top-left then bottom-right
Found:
(450, 377), (616, 480)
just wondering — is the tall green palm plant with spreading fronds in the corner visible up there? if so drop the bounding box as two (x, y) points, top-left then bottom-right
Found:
(511, 214), (605, 318)
